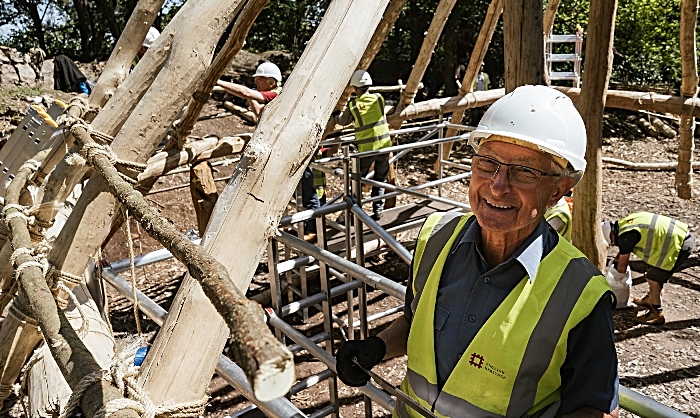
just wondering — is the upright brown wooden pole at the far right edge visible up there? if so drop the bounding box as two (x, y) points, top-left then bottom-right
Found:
(676, 0), (698, 199)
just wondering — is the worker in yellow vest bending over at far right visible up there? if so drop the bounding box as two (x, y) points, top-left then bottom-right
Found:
(601, 212), (695, 325)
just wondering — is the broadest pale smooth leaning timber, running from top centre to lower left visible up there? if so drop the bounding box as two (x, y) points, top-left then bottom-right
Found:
(140, 0), (388, 402)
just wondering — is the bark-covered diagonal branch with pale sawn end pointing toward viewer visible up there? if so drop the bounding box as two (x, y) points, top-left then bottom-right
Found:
(72, 127), (294, 405)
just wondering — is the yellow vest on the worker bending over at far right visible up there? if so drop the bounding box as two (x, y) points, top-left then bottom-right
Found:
(618, 212), (688, 271)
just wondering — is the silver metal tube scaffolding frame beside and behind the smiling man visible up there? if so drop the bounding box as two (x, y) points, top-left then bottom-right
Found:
(102, 122), (688, 418)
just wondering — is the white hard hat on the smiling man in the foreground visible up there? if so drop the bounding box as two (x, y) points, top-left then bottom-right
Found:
(469, 86), (587, 183)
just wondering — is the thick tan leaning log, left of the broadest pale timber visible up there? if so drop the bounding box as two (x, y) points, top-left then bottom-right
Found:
(49, 0), (246, 284)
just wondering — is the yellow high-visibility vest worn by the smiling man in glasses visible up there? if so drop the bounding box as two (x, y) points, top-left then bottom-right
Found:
(397, 214), (611, 417)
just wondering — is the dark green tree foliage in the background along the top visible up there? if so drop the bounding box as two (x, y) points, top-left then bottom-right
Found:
(0, 0), (696, 95)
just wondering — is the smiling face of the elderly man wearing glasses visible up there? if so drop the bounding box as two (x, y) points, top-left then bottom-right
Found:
(469, 141), (573, 240)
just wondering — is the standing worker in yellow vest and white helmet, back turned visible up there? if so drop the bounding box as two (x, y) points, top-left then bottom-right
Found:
(332, 70), (391, 220)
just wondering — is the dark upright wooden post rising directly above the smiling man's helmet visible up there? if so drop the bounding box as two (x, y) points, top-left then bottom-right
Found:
(503, 0), (545, 93)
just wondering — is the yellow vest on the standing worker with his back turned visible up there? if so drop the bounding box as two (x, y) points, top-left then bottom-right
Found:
(348, 93), (391, 152)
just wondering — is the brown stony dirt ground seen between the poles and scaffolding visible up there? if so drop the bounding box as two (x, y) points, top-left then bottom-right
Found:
(5, 97), (700, 418)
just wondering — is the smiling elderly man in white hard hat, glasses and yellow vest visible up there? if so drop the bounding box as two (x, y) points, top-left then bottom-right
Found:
(337, 86), (618, 417)
